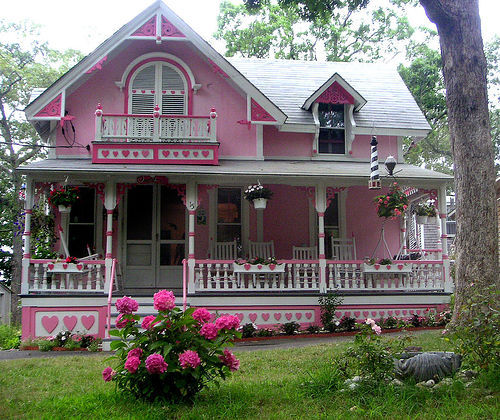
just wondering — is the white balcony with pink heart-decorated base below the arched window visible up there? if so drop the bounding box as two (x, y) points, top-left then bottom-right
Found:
(92, 104), (219, 165)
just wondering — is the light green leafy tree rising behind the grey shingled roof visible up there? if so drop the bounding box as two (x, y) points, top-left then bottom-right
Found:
(215, 0), (413, 61)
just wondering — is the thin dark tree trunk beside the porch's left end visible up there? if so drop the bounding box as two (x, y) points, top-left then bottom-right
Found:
(10, 172), (24, 325)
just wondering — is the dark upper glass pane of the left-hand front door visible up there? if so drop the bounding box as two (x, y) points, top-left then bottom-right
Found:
(127, 185), (153, 240)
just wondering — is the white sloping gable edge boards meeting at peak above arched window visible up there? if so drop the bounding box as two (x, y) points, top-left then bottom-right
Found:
(25, 0), (286, 123)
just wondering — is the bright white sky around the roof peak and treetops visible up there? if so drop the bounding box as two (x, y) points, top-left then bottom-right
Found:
(0, 0), (500, 54)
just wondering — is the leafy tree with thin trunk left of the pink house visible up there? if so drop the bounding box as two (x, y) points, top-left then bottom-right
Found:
(0, 21), (81, 323)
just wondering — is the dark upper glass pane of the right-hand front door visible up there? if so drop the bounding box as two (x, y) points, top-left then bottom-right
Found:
(160, 186), (186, 240)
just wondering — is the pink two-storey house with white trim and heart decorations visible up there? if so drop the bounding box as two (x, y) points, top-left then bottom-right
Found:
(22, 2), (452, 344)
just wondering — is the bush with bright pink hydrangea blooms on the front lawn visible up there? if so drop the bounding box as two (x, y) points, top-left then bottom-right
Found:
(102, 290), (241, 401)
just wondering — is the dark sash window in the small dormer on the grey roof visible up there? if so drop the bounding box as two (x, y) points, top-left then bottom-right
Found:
(318, 103), (345, 155)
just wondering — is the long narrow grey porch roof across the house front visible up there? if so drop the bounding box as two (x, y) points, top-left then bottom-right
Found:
(19, 159), (453, 185)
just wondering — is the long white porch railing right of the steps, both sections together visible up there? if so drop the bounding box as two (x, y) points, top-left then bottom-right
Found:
(194, 260), (445, 293)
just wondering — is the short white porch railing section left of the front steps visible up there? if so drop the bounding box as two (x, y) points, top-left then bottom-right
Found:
(28, 259), (105, 294)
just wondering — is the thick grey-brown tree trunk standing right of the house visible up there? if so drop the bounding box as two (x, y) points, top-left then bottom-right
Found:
(420, 0), (499, 323)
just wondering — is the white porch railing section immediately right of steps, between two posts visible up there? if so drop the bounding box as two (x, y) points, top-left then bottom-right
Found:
(194, 260), (319, 292)
